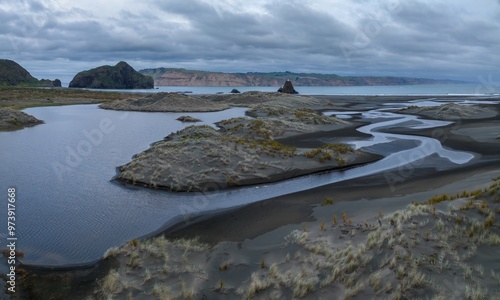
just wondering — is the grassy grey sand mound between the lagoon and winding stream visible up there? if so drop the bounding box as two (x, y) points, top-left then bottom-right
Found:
(117, 96), (373, 191)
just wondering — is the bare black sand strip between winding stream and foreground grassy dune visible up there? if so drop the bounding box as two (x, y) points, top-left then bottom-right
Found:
(166, 159), (500, 243)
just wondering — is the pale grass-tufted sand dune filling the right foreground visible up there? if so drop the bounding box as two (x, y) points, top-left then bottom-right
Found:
(86, 179), (500, 299)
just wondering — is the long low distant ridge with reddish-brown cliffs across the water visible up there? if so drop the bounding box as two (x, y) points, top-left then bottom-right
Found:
(139, 68), (462, 86)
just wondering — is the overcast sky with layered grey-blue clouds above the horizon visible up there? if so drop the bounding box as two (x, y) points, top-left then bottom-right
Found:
(0, 0), (500, 83)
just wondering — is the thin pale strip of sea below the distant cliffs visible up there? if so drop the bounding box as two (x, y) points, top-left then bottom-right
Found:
(78, 83), (500, 96)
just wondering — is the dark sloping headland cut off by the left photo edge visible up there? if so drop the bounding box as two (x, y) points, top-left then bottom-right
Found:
(0, 59), (61, 87)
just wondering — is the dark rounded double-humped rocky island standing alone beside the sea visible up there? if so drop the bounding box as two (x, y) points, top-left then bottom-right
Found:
(69, 61), (154, 89)
